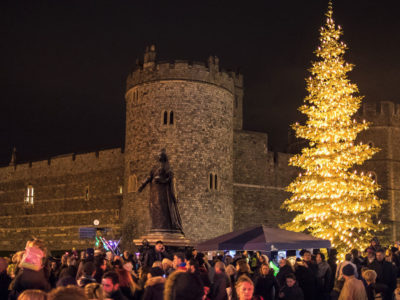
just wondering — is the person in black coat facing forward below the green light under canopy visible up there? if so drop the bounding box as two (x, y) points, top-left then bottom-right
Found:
(254, 263), (279, 300)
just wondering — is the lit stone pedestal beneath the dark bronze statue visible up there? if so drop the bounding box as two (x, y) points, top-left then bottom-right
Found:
(133, 230), (192, 247)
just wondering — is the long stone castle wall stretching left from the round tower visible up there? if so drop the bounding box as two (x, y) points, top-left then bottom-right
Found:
(0, 149), (123, 250)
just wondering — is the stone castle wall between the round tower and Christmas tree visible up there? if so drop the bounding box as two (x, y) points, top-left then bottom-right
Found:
(233, 131), (297, 229)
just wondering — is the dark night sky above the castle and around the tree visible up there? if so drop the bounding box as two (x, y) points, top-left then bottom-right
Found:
(0, 0), (400, 164)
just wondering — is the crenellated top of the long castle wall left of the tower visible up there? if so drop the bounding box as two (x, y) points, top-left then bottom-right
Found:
(0, 148), (124, 182)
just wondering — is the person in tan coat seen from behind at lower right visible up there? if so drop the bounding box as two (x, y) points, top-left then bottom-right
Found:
(339, 264), (368, 300)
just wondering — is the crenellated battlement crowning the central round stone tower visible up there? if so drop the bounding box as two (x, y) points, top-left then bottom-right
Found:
(127, 46), (243, 93)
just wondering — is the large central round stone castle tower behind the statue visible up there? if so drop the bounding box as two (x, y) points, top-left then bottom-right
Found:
(121, 46), (243, 244)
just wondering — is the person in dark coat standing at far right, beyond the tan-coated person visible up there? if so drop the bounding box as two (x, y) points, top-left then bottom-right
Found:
(371, 248), (396, 300)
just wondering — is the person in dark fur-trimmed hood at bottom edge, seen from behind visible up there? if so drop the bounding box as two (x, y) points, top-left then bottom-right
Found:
(164, 271), (207, 300)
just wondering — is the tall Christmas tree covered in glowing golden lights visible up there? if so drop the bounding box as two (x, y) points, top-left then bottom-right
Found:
(282, 3), (383, 254)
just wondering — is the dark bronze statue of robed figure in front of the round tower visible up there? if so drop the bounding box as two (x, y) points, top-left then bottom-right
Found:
(138, 149), (183, 234)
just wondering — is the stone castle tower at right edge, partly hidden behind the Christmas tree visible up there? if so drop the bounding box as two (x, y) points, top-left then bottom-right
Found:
(357, 101), (400, 241)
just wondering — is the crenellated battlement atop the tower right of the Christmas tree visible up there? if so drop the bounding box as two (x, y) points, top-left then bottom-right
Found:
(356, 101), (400, 127)
